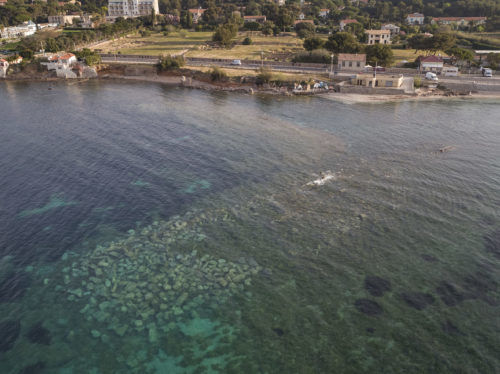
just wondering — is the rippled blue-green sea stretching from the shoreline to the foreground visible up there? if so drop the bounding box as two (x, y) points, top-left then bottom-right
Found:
(0, 82), (500, 374)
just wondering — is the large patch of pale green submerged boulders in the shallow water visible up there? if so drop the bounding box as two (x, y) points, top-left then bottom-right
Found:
(56, 212), (262, 343)
